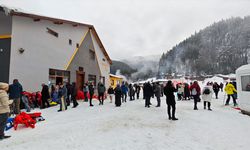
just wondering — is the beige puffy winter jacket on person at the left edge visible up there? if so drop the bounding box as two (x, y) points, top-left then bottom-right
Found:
(0, 90), (13, 114)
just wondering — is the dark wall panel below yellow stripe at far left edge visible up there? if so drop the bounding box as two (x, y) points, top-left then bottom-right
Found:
(0, 36), (11, 83)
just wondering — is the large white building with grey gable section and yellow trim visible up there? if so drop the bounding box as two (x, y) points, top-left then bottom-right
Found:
(0, 6), (112, 92)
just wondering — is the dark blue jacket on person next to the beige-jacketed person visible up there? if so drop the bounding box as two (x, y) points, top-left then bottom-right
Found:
(9, 82), (23, 99)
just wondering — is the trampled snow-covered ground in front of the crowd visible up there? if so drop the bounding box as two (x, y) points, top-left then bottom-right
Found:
(0, 92), (250, 150)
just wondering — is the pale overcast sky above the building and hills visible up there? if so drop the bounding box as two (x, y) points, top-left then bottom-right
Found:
(0, 0), (250, 59)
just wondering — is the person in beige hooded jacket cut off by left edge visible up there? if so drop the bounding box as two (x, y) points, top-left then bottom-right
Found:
(0, 82), (13, 140)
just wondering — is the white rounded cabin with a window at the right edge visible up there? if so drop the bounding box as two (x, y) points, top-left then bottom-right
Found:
(236, 64), (250, 114)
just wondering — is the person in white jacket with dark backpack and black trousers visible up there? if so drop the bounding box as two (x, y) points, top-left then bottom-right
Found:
(201, 83), (213, 111)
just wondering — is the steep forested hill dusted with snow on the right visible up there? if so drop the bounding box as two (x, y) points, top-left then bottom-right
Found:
(159, 16), (250, 75)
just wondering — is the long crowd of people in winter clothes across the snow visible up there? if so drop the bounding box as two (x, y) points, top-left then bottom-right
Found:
(0, 79), (237, 140)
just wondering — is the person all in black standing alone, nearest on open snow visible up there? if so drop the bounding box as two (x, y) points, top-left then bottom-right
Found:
(164, 80), (178, 120)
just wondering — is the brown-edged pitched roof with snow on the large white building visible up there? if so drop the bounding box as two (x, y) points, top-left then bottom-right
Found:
(0, 5), (112, 64)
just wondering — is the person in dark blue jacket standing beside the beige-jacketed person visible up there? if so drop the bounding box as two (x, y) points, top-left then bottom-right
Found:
(9, 79), (23, 114)
